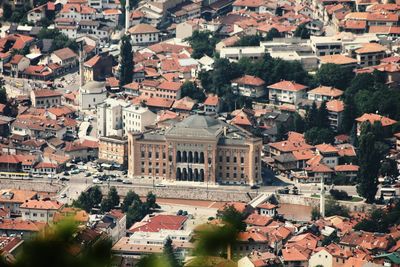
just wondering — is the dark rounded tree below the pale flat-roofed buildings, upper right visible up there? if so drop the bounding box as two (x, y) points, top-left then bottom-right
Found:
(315, 64), (354, 89)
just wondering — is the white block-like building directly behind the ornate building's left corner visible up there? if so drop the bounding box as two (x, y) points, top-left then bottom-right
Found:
(122, 105), (157, 135)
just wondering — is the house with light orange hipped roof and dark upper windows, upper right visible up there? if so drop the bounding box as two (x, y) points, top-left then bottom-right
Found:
(354, 43), (387, 67)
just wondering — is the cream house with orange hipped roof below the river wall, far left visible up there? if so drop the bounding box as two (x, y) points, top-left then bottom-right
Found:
(20, 199), (63, 223)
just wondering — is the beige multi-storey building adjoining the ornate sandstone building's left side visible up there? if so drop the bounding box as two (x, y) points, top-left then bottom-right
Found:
(99, 136), (128, 166)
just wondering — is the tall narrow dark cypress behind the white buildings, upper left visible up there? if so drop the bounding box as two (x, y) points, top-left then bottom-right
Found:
(119, 35), (133, 86)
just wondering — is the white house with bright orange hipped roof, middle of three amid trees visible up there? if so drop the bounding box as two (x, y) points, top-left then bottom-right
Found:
(267, 81), (308, 105)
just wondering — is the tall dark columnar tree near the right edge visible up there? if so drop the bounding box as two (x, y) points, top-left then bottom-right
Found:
(357, 123), (382, 203)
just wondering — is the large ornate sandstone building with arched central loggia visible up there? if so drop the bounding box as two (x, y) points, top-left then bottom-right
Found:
(128, 115), (262, 185)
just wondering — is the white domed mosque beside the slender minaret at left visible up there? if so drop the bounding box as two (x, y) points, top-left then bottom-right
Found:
(79, 81), (107, 110)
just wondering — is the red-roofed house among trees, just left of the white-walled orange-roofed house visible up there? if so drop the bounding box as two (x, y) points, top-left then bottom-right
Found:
(231, 75), (266, 98)
